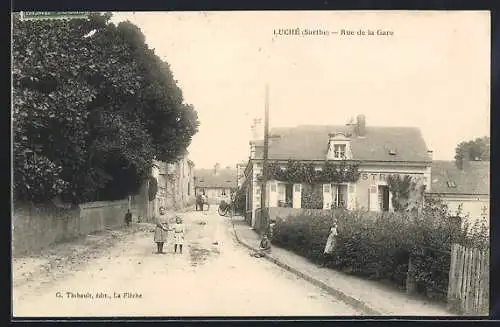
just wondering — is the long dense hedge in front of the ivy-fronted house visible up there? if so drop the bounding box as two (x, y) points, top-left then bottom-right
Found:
(272, 207), (484, 300)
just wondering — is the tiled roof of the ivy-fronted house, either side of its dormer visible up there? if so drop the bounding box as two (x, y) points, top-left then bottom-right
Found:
(256, 125), (430, 162)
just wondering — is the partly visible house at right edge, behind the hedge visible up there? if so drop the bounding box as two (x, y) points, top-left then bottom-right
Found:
(428, 161), (490, 227)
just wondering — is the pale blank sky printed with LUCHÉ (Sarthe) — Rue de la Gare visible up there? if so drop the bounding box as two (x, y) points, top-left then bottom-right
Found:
(112, 11), (490, 168)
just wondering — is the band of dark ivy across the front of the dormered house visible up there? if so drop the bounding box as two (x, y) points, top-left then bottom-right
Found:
(259, 160), (360, 185)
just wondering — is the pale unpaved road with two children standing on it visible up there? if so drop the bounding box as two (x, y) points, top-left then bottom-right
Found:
(13, 212), (361, 317)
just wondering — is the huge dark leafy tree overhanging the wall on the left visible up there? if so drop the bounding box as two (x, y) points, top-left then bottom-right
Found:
(12, 14), (199, 203)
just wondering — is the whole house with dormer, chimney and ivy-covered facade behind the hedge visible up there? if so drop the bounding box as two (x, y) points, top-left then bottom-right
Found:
(239, 115), (432, 226)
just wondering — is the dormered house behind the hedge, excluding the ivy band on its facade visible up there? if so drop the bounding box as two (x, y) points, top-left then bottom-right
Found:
(239, 115), (432, 226)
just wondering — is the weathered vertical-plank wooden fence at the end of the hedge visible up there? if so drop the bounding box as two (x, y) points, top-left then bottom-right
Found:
(448, 244), (490, 315)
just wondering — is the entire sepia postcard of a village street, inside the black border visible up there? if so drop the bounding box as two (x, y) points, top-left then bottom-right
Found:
(12, 11), (490, 318)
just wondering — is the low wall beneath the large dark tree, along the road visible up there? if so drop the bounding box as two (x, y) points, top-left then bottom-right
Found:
(12, 200), (132, 256)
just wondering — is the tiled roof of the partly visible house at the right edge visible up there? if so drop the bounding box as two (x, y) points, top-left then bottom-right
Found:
(431, 161), (490, 195)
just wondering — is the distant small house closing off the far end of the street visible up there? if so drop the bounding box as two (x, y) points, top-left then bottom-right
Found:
(195, 164), (237, 204)
